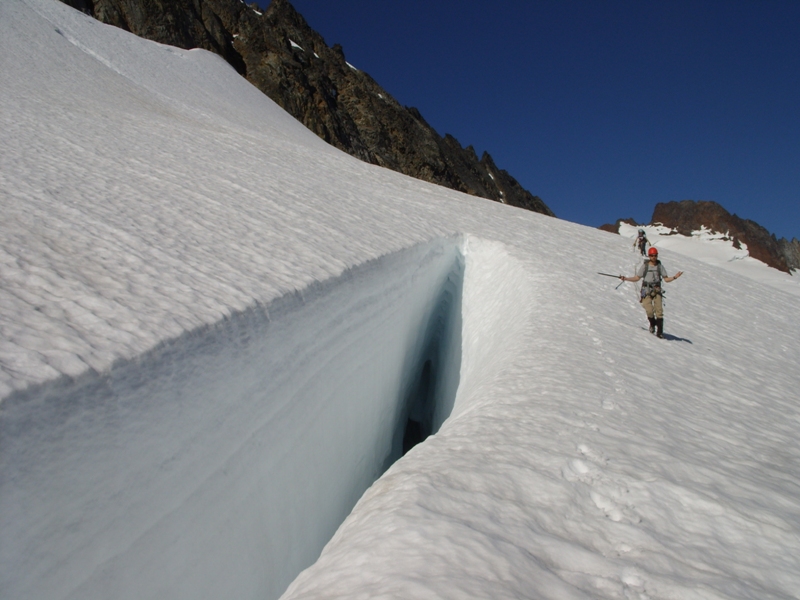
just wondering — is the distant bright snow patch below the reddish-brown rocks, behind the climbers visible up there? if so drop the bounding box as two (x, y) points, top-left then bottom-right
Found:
(619, 223), (800, 296)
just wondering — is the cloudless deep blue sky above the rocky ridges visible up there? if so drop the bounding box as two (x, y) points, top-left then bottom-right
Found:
(276, 0), (800, 239)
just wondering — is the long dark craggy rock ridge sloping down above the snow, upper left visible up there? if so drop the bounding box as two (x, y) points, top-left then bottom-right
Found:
(62, 0), (553, 216)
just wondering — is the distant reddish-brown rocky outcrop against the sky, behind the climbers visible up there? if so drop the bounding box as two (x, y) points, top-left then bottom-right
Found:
(600, 200), (800, 273)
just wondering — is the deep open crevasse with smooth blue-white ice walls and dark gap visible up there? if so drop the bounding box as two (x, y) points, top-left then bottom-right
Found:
(0, 234), (536, 600)
